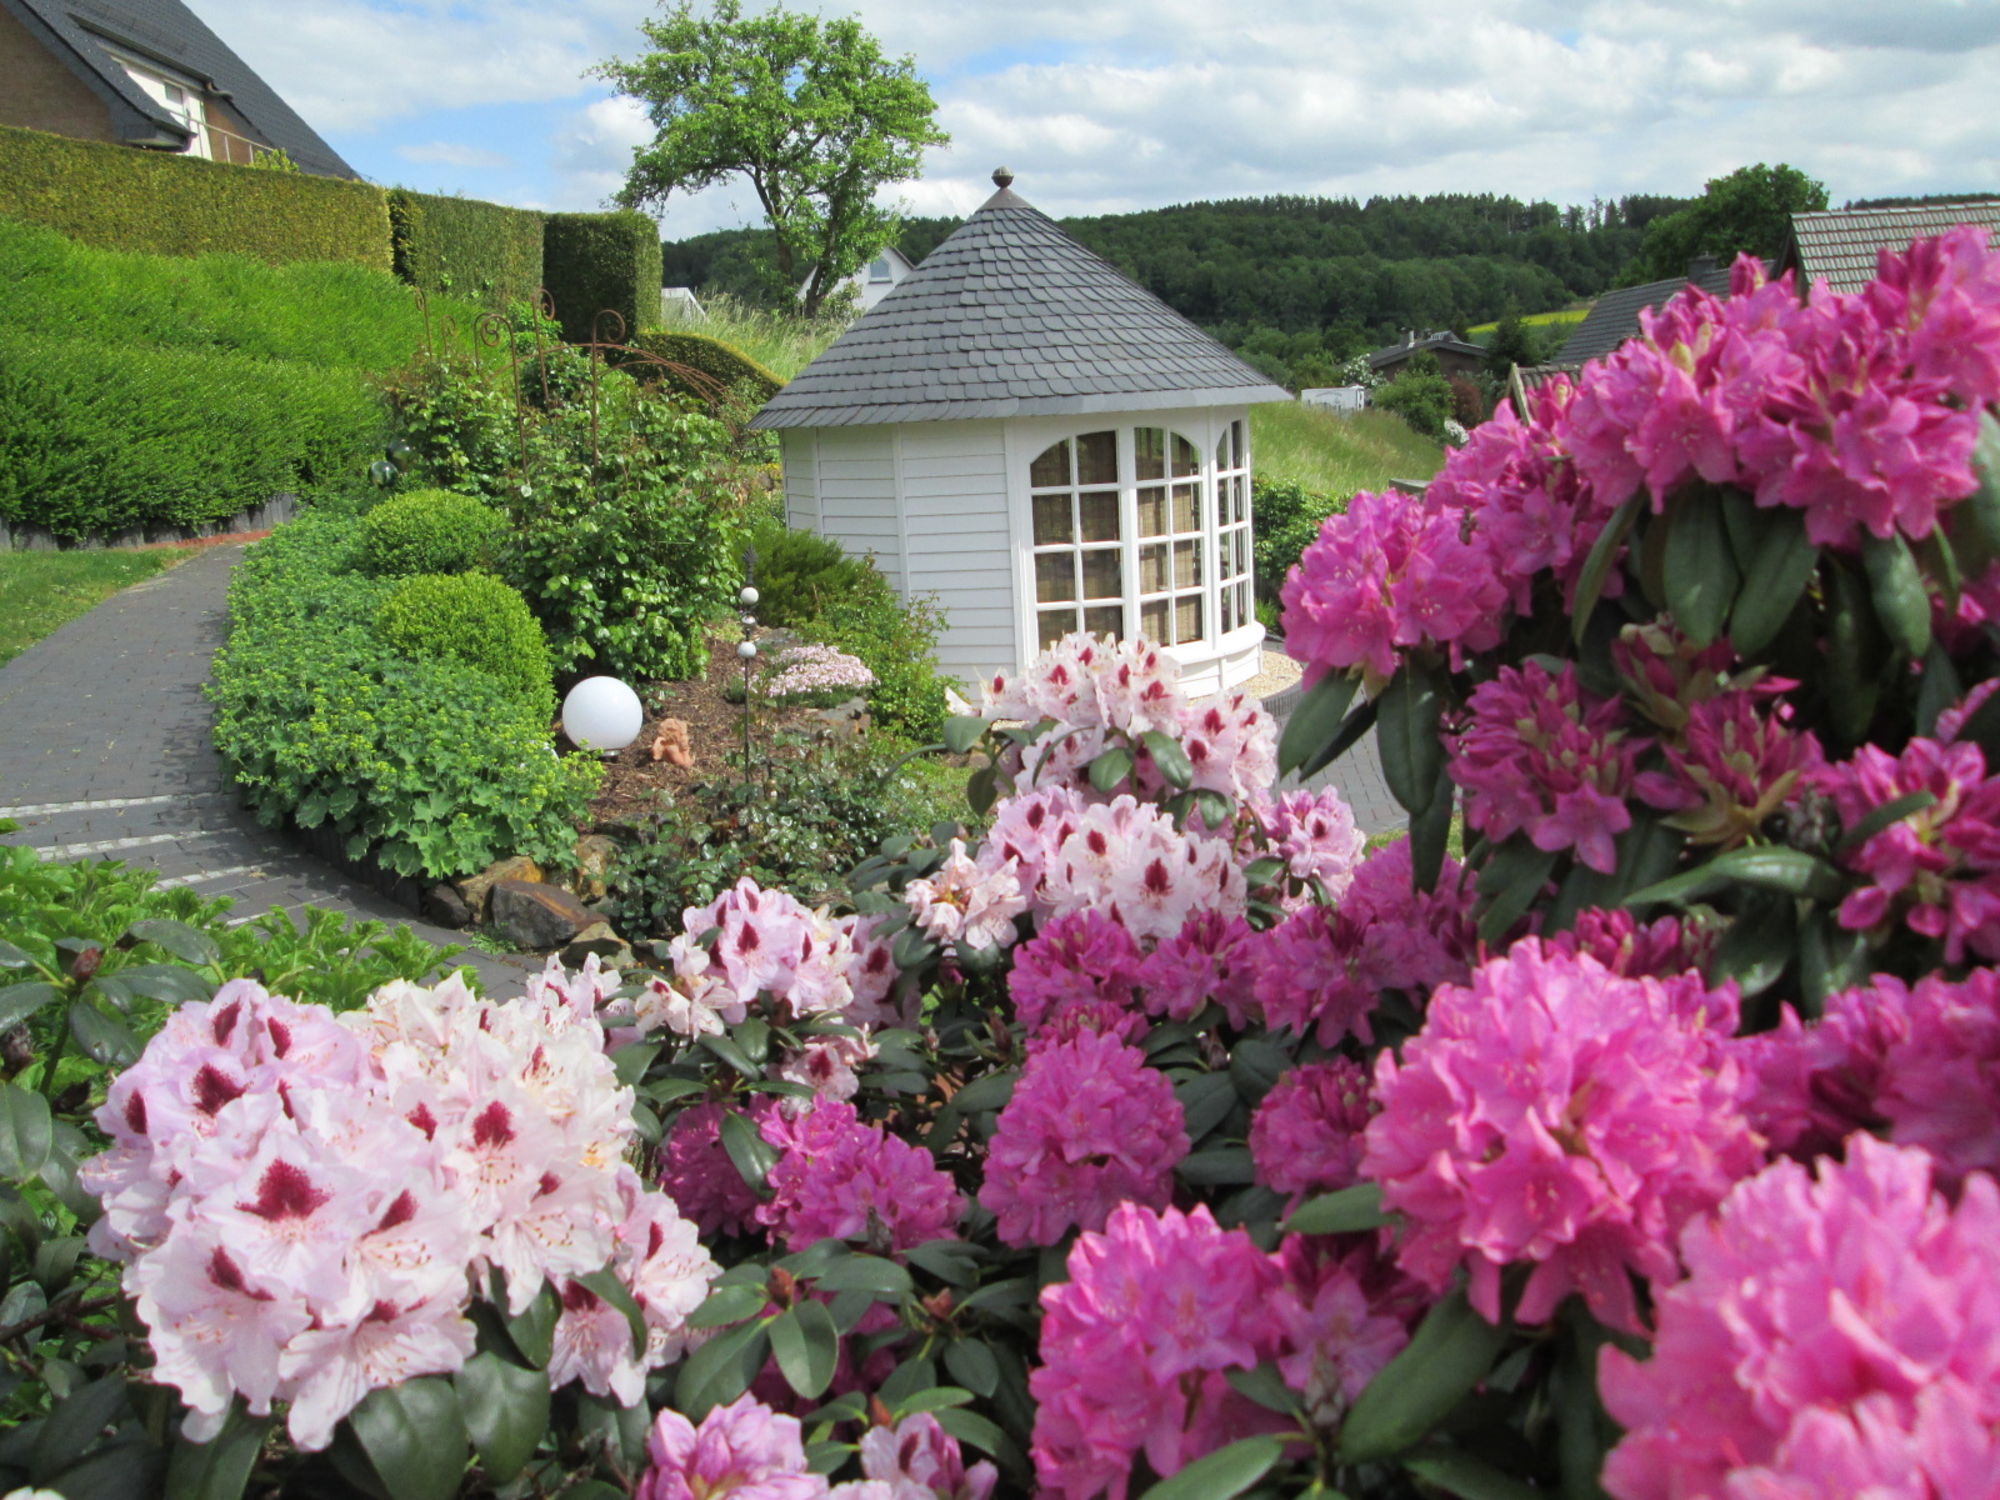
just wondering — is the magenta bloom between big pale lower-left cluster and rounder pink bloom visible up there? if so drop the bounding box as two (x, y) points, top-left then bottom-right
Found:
(756, 1098), (964, 1254)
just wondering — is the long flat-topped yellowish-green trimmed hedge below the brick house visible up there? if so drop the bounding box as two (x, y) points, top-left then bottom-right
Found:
(0, 126), (392, 272)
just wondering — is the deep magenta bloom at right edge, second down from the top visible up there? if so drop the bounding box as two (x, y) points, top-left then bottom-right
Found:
(1816, 738), (2000, 964)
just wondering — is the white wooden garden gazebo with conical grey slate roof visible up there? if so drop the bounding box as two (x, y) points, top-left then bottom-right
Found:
(752, 168), (1290, 696)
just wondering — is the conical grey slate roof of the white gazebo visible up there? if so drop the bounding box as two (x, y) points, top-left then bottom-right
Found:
(750, 172), (1292, 428)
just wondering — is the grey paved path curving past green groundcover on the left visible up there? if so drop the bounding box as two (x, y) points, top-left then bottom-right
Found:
(0, 542), (528, 994)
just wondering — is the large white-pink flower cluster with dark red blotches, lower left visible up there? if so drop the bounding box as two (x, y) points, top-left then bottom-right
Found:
(84, 970), (718, 1448)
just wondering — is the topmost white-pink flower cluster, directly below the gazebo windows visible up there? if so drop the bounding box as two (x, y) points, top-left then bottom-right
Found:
(980, 632), (1278, 798)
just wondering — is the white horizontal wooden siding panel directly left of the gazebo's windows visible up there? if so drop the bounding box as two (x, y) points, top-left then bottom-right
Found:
(898, 422), (1016, 686)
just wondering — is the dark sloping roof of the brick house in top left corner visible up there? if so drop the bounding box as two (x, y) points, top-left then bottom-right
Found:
(0, 0), (360, 178)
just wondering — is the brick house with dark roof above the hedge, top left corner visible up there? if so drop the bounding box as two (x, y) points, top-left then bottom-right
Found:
(0, 0), (360, 178)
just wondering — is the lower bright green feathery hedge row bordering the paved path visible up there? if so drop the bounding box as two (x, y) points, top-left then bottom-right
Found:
(0, 330), (386, 538)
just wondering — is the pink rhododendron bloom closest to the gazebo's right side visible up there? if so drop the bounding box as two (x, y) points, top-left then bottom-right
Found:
(1282, 492), (1506, 680)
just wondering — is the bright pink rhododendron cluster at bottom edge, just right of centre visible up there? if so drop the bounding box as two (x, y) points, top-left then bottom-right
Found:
(1028, 1204), (1406, 1500)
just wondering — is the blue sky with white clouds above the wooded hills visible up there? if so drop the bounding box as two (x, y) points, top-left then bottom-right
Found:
(190, 0), (2000, 238)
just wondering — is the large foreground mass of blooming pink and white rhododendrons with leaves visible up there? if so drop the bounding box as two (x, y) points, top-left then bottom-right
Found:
(11, 232), (2000, 1500)
